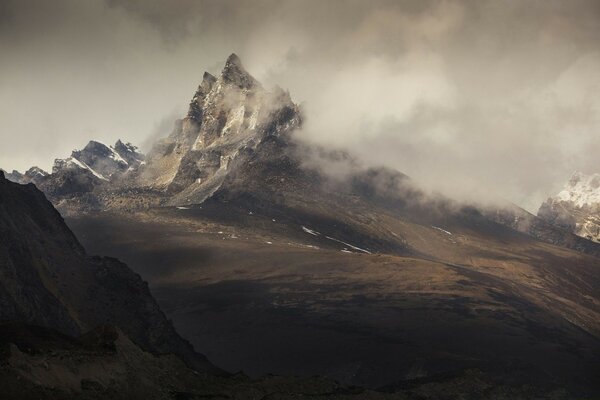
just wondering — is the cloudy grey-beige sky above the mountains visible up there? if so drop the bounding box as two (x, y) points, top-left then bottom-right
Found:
(0, 0), (600, 210)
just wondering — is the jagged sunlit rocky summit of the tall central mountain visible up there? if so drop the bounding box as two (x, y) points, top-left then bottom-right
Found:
(141, 54), (300, 204)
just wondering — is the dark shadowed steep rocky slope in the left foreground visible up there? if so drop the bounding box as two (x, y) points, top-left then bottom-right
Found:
(0, 173), (211, 369)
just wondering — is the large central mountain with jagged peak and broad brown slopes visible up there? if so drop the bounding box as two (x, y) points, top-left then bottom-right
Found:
(4, 55), (600, 398)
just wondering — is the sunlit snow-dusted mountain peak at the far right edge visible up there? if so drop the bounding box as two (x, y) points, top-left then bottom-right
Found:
(538, 172), (600, 242)
